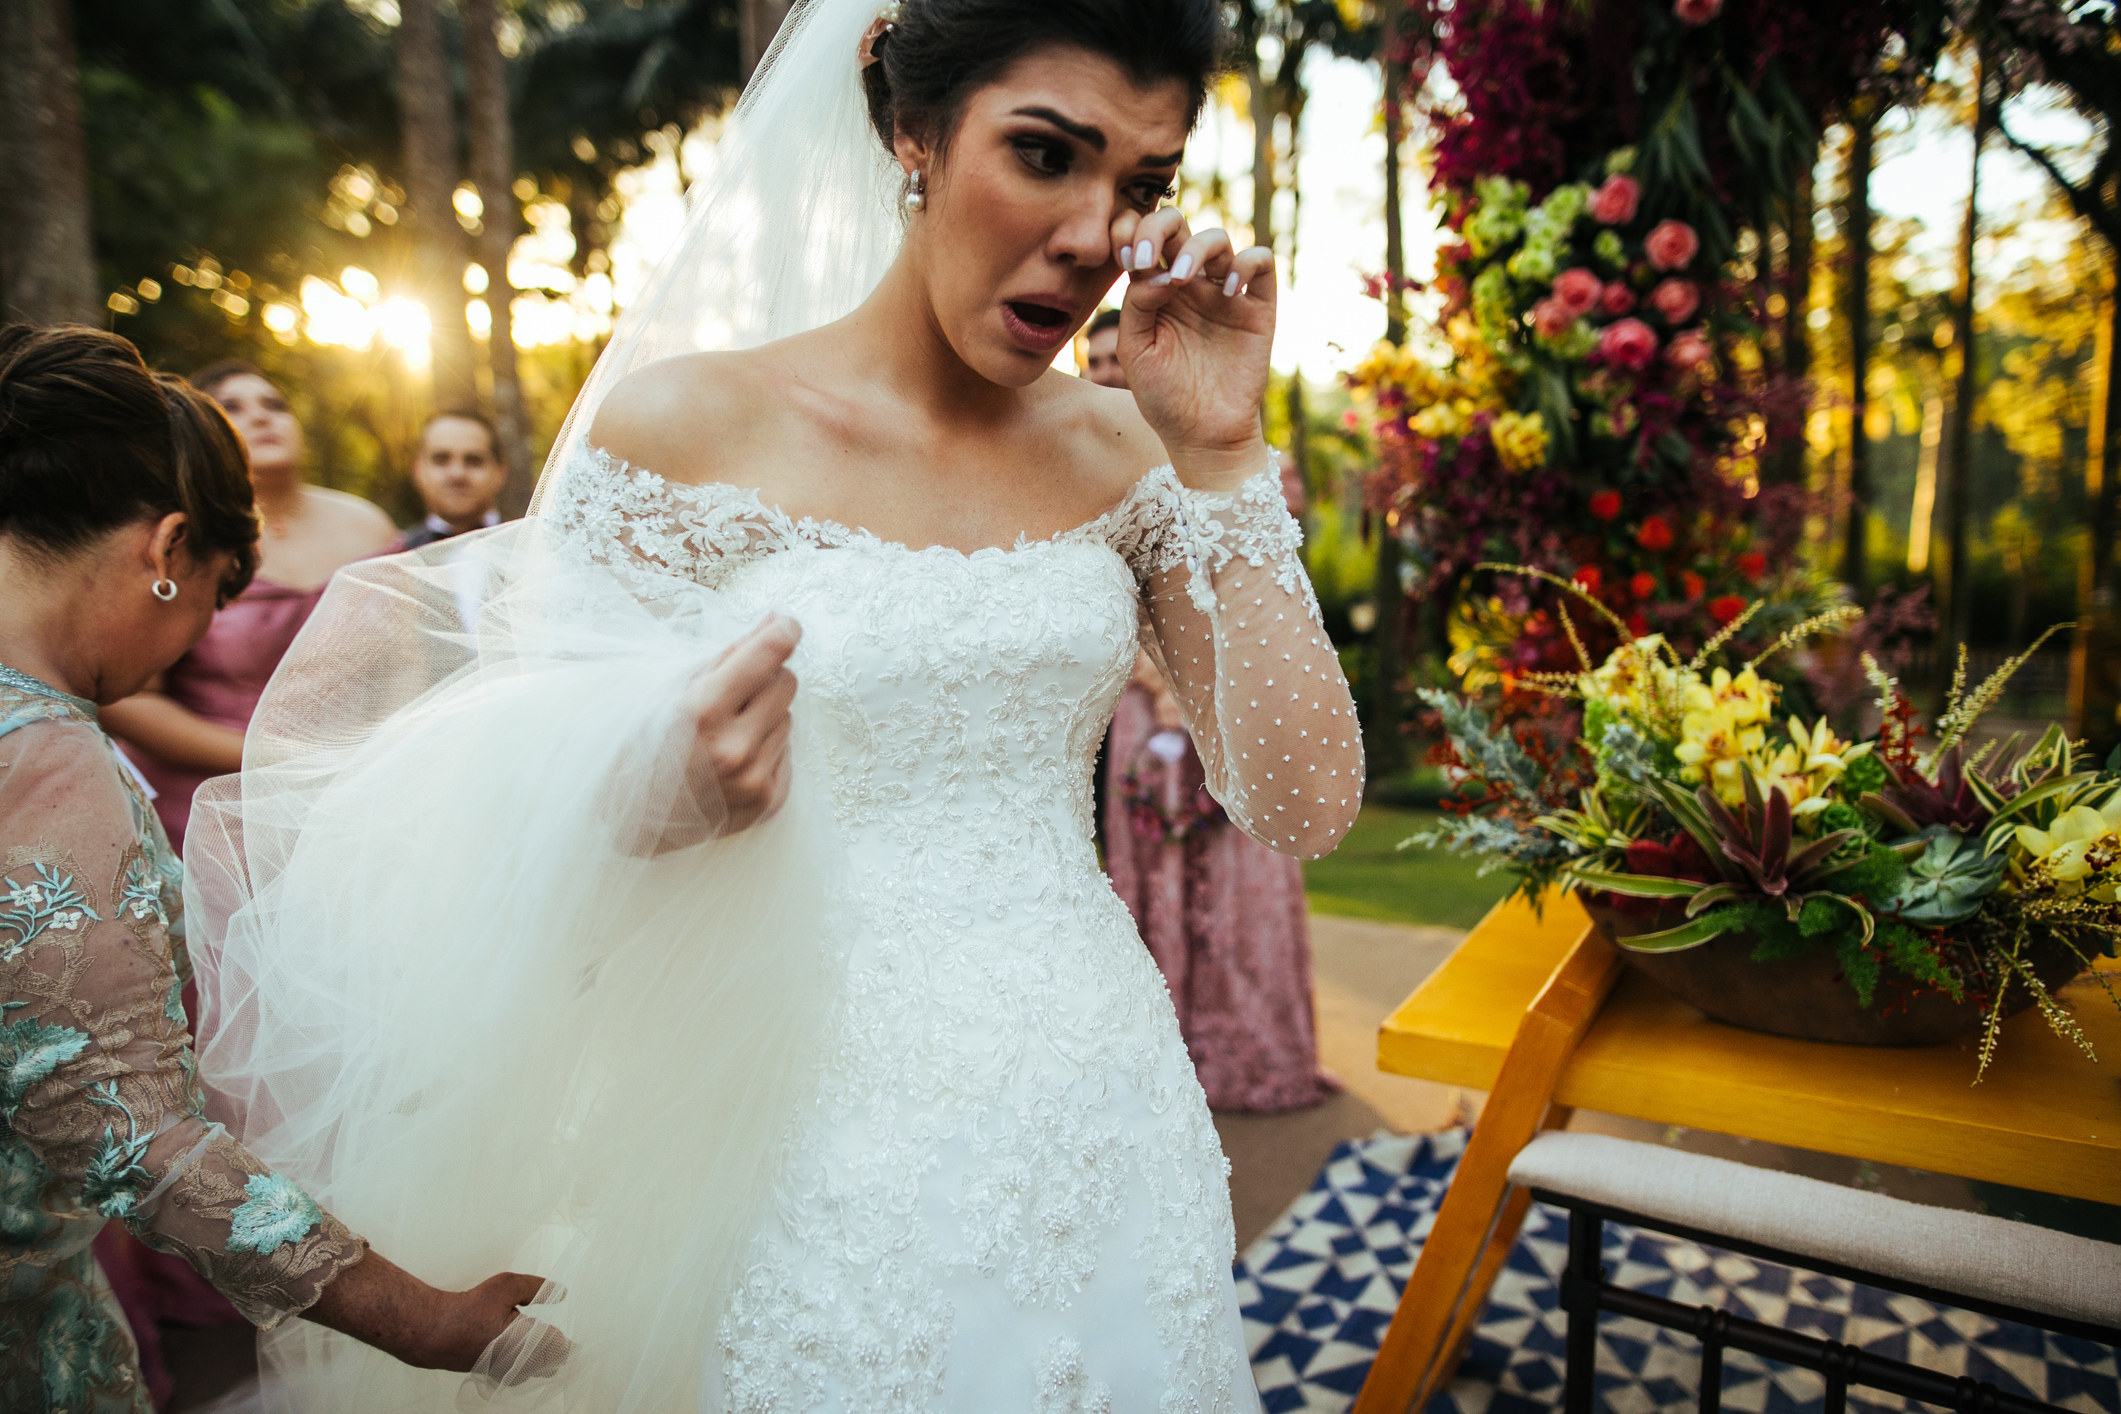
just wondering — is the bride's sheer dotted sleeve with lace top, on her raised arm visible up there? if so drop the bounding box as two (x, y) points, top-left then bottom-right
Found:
(1122, 469), (1364, 859)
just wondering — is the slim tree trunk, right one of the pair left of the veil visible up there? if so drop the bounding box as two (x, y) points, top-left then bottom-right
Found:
(458, 0), (537, 515)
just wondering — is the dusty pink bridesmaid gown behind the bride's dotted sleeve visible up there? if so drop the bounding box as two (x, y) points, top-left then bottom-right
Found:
(1105, 683), (1338, 1111)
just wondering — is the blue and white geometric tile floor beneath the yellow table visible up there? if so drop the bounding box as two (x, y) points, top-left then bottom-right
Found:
(1237, 1130), (2121, 1414)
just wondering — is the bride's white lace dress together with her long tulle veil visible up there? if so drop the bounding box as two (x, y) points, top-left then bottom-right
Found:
(187, 0), (1362, 1414)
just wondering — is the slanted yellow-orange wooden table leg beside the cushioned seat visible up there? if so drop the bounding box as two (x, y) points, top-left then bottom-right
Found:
(1355, 926), (1620, 1414)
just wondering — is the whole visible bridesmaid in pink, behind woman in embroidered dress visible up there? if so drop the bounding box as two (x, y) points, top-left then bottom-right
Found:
(95, 363), (397, 1406)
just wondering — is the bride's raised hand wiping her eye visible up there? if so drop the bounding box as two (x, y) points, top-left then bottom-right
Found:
(1111, 208), (1275, 490)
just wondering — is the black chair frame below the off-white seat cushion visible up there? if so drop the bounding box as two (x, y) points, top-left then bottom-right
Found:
(1531, 1187), (2121, 1414)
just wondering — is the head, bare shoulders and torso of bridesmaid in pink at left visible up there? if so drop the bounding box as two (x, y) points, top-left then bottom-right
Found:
(104, 360), (397, 850)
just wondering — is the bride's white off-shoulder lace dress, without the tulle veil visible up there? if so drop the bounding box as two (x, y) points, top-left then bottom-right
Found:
(554, 452), (1362, 1414)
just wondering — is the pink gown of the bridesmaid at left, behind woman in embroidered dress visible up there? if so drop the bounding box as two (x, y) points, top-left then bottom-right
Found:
(95, 579), (325, 1406)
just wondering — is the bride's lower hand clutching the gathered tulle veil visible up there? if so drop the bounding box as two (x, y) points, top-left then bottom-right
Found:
(664, 615), (802, 848)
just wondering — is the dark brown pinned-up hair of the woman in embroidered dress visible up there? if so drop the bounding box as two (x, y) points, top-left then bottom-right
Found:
(0, 324), (259, 596)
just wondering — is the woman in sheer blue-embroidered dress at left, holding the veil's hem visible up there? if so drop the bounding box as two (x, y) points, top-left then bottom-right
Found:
(0, 326), (543, 1414)
